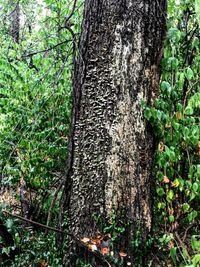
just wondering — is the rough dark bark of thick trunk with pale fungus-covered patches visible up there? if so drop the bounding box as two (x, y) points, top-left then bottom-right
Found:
(64, 0), (166, 266)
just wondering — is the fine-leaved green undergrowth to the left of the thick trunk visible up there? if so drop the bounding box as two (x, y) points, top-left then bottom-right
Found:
(0, 0), (81, 266)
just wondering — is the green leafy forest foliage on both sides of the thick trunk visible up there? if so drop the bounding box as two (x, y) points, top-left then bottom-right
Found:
(0, 0), (200, 267)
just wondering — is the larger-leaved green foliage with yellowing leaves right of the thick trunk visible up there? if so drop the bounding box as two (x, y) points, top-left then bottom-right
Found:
(145, 1), (200, 266)
